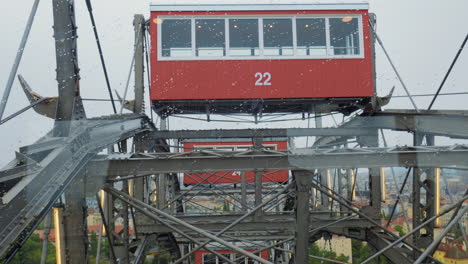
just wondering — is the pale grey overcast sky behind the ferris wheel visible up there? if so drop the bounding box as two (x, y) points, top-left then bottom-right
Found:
(0, 0), (468, 165)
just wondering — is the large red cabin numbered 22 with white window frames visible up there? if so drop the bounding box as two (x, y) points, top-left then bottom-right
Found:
(150, 0), (375, 116)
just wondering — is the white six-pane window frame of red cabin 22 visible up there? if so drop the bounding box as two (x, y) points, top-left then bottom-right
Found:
(156, 14), (367, 61)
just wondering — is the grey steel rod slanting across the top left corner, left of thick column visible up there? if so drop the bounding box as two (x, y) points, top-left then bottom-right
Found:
(0, 0), (39, 120)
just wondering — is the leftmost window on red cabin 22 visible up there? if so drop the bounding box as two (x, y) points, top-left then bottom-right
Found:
(161, 19), (192, 57)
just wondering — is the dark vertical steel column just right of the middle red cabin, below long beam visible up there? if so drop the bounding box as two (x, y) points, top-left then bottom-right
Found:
(294, 171), (313, 264)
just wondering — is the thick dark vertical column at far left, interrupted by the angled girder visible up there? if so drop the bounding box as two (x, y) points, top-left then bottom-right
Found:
(52, 0), (88, 263)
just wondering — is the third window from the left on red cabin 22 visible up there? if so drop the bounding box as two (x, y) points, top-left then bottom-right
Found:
(229, 19), (260, 56)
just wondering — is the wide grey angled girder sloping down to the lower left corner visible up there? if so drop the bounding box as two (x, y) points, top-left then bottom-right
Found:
(0, 116), (148, 262)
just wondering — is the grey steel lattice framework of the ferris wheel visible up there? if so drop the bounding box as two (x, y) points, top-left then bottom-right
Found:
(0, 0), (468, 263)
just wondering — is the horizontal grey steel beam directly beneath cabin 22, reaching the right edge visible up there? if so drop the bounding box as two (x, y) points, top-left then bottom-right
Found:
(153, 110), (468, 139)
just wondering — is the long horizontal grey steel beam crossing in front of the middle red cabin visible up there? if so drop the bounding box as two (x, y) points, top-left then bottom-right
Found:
(88, 145), (468, 177)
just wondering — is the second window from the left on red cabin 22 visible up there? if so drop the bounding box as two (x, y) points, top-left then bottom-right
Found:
(195, 19), (226, 57)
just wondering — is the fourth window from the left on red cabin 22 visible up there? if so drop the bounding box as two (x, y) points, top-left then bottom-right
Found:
(263, 19), (294, 56)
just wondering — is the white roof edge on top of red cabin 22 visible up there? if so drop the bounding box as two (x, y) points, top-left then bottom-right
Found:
(151, 0), (369, 11)
